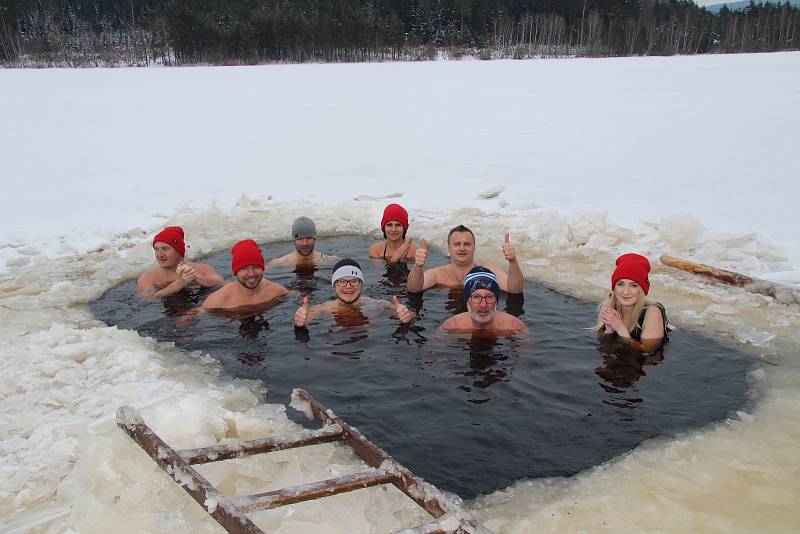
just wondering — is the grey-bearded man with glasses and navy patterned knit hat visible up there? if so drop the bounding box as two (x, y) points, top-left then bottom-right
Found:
(441, 265), (528, 335)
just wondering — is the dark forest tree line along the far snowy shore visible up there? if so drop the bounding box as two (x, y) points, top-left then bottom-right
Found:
(0, 0), (800, 66)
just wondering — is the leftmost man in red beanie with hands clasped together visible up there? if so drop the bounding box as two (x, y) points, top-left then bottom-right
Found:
(136, 226), (224, 299)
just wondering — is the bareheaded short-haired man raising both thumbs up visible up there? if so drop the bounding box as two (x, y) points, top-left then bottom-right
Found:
(408, 225), (523, 294)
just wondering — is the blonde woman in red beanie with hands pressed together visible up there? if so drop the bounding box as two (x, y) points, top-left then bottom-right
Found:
(595, 254), (671, 352)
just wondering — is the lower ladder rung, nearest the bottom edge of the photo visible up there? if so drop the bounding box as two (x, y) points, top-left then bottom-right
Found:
(228, 469), (395, 513)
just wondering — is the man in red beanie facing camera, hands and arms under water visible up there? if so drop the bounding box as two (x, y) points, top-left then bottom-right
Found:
(202, 239), (288, 310)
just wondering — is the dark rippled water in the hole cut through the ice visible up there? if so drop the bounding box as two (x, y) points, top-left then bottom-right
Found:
(92, 237), (752, 498)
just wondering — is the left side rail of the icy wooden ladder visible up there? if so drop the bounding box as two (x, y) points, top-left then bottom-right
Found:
(117, 406), (264, 534)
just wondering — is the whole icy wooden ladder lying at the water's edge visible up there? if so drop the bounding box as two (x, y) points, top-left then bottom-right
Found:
(117, 389), (490, 534)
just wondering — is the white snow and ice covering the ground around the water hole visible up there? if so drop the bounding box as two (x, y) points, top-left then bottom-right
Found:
(0, 53), (800, 532)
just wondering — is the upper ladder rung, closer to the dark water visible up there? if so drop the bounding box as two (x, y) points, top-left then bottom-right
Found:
(177, 425), (344, 465)
